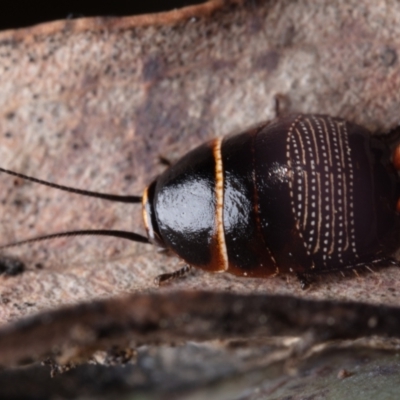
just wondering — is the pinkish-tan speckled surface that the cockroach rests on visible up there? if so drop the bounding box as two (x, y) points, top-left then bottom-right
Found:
(0, 0), (400, 322)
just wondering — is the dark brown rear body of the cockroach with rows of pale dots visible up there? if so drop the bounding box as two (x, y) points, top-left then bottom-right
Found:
(255, 115), (397, 273)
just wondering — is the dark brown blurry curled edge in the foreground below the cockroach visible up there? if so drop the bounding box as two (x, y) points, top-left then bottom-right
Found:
(0, 291), (400, 365)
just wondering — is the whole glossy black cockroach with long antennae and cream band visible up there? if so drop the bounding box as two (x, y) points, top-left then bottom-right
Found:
(0, 114), (400, 287)
